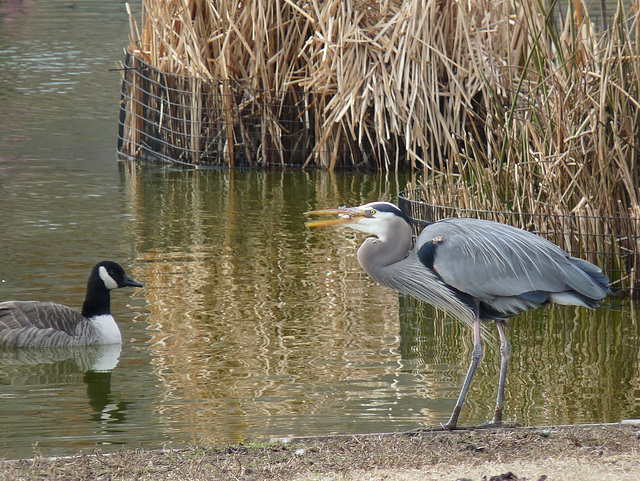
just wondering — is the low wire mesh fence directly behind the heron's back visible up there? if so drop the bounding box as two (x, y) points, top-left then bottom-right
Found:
(398, 191), (640, 297)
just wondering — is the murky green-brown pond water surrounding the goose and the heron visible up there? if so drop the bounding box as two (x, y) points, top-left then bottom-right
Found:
(0, 1), (640, 458)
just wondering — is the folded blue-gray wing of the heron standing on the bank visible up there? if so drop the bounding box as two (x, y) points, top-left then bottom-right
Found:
(417, 219), (605, 302)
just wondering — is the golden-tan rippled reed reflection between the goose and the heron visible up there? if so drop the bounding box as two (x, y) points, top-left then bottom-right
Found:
(126, 164), (418, 442)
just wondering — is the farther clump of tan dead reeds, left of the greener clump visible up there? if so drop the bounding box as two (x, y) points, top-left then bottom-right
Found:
(122, 0), (544, 170)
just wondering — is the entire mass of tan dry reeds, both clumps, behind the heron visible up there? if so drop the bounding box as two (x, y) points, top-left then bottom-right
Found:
(119, 0), (640, 286)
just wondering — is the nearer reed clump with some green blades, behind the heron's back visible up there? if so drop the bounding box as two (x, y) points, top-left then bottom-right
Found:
(404, 1), (640, 295)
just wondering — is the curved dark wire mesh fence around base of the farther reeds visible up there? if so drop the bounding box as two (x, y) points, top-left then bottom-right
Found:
(118, 53), (380, 168)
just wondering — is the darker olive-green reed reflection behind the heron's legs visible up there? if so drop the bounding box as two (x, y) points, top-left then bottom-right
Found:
(400, 298), (640, 425)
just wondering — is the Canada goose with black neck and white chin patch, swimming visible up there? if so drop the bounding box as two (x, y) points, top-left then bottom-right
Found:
(0, 261), (142, 347)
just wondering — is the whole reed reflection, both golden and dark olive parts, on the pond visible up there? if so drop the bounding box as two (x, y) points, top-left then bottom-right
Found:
(123, 163), (640, 443)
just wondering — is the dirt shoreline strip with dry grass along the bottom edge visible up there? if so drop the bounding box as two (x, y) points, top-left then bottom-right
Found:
(0, 420), (640, 481)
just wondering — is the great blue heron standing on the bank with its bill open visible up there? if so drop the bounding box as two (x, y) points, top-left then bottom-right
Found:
(306, 202), (610, 429)
